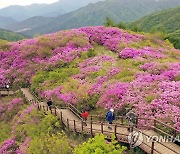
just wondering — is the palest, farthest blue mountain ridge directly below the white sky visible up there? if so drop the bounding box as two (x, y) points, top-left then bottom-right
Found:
(0, 0), (99, 21)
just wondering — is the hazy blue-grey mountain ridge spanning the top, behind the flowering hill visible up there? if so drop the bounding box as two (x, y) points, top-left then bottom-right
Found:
(0, 0), (180, 37)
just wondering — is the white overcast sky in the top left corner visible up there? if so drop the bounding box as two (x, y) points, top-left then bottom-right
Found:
(0, 0), (58, 8)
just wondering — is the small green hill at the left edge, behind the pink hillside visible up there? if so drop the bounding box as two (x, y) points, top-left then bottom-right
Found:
(0, 29), (26, 41)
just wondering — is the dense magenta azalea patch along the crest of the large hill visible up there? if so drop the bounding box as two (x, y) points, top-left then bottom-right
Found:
(79, 26), (143, 52)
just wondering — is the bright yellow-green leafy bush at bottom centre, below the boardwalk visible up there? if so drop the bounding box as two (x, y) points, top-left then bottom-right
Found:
(74, 134), (126, 154)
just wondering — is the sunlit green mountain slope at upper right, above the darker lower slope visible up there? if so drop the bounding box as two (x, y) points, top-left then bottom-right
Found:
(130, 7), (180, 33)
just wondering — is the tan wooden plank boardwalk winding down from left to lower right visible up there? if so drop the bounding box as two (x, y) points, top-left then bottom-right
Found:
(21, 88), (180, 154)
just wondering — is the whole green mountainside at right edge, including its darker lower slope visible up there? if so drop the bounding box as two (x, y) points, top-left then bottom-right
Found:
(129, 7), (180, 49)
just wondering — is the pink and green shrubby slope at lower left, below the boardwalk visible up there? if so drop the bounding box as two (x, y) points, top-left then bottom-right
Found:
(0, 96), (70, 154)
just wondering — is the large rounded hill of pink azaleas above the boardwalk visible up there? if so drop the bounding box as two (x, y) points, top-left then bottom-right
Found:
(0, 27), (180, 130)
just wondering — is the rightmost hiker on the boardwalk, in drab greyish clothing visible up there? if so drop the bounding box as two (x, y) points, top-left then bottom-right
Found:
(126, 107), (137, 132)
